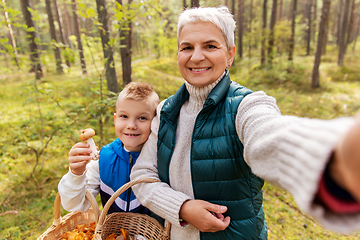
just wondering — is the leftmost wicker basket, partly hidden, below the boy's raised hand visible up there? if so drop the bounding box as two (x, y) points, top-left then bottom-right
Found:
(37, 190), (100, 240)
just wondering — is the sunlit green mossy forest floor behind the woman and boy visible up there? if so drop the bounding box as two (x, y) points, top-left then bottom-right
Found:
(0, 47), (360, 240)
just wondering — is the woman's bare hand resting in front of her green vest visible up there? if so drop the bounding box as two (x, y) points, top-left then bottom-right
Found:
(179, 200), (230, 232)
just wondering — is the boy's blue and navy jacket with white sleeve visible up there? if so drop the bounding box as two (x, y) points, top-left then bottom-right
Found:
(58, 138), (148, 213)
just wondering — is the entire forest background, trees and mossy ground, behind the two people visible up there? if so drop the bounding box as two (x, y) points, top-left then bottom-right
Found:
(0, 0), (360, 239)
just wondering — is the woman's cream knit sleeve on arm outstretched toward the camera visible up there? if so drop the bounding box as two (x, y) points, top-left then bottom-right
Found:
(236, 92), (360, 233)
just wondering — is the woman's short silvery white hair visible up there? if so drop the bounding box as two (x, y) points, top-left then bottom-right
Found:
(177, 6), (236, 50)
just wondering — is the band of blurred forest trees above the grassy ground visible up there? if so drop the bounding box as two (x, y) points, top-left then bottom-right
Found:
(0, 0), (360, 92)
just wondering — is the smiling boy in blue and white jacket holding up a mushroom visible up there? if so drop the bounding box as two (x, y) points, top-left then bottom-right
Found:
(58, 82), (159, 213)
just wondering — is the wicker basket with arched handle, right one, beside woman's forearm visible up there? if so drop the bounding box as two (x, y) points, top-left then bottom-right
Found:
(95, 178), (171, 240)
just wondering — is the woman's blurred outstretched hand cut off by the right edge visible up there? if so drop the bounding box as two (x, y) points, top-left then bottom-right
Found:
(329, 112), (360, 202)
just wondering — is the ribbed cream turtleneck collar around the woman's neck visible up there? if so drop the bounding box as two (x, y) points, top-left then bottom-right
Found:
(184, 70), (228, 112)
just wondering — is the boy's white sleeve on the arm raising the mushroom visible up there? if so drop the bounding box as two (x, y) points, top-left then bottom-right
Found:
(58, 160), (100, 212)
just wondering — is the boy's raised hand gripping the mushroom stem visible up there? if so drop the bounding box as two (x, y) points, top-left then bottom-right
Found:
(69, 142), (92, 175)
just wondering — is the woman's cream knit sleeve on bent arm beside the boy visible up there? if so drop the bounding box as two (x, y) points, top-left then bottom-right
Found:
(130, 103), (190, 226)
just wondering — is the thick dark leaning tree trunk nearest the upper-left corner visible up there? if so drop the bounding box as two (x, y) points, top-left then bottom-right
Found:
(20, 0), (43, 79)
